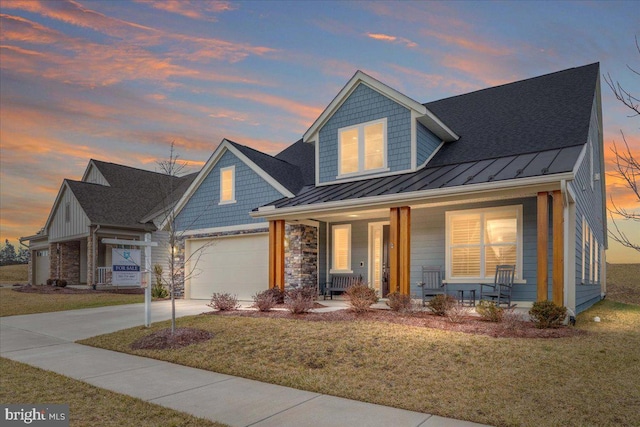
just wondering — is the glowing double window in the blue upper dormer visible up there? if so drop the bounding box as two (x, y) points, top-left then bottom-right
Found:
(338, 118), (387, 176)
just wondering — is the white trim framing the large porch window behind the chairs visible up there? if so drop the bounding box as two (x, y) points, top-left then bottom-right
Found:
(445, 205), (526, 283)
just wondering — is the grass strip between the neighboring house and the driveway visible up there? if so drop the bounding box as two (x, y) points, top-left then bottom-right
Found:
(0, 288), (144, 316)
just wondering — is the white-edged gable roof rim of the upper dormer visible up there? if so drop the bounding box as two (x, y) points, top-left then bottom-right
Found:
(302, 70), (458, 142)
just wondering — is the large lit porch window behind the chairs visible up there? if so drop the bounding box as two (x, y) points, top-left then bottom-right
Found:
(446, 206), (522, 281)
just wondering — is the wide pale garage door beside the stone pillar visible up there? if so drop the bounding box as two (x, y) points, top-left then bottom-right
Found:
(186, 234), (269, 301)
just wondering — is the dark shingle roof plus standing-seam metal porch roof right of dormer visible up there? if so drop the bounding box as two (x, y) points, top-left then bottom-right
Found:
(254, 64), (599, 216)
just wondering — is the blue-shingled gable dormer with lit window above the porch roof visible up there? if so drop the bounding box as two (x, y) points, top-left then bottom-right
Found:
(303, 71), (458, 185)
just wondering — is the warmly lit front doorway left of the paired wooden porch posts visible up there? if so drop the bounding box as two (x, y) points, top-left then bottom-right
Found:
(369, 222), (389, 297)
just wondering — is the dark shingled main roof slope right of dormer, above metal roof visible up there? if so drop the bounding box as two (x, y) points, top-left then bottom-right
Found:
(425, 63), (599, 166)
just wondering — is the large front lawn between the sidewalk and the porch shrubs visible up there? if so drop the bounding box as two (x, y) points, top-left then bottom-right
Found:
(81, 301), (640, 426)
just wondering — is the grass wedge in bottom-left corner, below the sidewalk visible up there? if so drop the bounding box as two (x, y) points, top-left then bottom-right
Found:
(0, 358), (224, 427)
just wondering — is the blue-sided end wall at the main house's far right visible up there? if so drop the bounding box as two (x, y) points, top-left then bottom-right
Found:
(570, 99), (606, 312)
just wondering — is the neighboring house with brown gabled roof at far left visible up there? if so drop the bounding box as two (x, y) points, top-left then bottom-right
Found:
(20, 160), (196, 285)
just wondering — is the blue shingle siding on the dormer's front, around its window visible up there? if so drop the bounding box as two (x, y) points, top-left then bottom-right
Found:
(319, 84), (411, 183)
